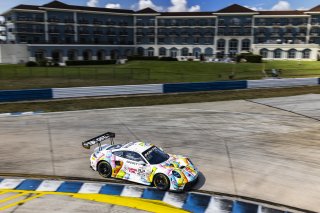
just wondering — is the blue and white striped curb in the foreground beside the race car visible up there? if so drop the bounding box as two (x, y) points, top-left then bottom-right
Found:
(0, 178), (296, 213)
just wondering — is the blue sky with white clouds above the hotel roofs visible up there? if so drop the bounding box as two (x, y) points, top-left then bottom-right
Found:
(0, 0), (320, 14)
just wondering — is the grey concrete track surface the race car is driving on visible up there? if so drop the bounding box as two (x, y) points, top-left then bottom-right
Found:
(0, 95), (320, 212)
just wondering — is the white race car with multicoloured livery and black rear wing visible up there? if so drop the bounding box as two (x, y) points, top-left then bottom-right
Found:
(82, 132), (199, 191)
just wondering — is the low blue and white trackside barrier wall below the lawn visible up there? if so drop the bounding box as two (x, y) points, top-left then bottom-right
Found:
(0, 78), (320, 102)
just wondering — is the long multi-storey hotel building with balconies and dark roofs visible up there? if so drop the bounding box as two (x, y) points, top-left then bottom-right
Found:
(0, 1), (320, 63)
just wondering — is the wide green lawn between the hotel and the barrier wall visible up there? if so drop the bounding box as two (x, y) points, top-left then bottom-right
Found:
(0, 61), (320, 89)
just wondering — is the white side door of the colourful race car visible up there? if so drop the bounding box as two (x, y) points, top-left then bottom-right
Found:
(124, 151), (149, 184)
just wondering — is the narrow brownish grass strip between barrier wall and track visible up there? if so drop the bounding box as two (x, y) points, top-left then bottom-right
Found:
(0, 86), (320, 113)
